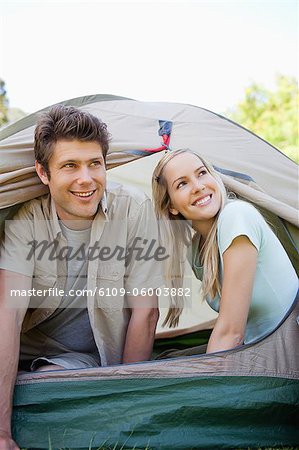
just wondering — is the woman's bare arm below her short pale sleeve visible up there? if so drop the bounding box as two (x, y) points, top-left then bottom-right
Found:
(207, 236), (258, 353)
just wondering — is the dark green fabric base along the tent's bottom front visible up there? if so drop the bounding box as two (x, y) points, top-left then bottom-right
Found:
(14, 376), (299, 450)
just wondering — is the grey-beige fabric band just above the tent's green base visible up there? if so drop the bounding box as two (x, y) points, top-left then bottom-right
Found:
(17, 298), (299, 385)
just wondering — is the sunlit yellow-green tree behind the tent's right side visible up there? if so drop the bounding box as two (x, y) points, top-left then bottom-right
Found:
(227, 75), (299, 162)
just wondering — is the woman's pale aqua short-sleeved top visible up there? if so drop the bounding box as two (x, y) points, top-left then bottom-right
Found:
(193, 200), (298, 344)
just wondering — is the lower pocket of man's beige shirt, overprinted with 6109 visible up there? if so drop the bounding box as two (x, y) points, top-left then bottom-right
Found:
(96, 262), (125, 311)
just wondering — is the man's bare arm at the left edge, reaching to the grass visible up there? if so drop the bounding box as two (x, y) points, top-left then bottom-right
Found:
(0, 270), (31, 450)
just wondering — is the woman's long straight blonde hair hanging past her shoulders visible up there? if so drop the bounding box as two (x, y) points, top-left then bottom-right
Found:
(152, 149), (228, 327)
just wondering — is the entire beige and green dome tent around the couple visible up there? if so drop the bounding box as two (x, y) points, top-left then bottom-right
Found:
(0, 95), (299, 450)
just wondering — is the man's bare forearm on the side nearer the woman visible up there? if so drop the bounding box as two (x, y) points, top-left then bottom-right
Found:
(123, 294), (159, 364)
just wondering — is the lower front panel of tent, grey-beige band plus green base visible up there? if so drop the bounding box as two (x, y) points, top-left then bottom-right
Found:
(13, 303), (299, 450)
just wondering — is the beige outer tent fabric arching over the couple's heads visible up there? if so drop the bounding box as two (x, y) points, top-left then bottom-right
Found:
(0, 95), (298, 226)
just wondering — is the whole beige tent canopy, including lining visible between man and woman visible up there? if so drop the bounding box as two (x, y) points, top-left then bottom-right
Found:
(0, 95), (298, 334)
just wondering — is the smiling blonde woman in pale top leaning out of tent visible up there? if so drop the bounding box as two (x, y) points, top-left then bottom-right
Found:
(152, 149), (298, 352)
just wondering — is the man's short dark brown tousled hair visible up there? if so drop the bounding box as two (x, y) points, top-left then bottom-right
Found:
(34, 105), (110, 176)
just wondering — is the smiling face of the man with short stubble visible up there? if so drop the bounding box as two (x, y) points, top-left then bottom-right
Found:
(36, 140), (106, 228)
